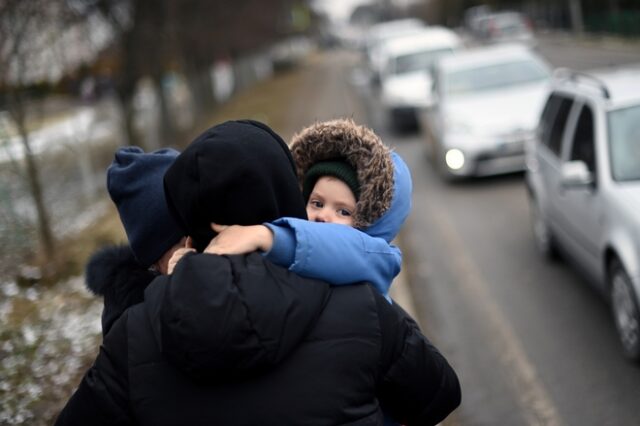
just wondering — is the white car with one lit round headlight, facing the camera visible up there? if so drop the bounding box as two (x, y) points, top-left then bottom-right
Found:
(423, 45), (551, 179)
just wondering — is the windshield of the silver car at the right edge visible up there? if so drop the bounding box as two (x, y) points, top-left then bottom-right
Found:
(608, 105), (640, 181)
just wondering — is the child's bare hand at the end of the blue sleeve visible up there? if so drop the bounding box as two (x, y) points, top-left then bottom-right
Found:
(204, 223), (273, 254)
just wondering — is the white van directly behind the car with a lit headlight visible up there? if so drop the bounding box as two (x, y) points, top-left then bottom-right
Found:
(380, 27), (462, 128)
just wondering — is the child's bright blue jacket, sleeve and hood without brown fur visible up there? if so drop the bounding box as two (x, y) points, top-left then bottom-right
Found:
(265, 152), (412, 299)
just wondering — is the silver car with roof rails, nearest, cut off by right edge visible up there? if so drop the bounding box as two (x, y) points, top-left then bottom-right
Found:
(526, 66), (640, 361)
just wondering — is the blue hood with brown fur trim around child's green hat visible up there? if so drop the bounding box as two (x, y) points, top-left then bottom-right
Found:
(290, 118), (412, 241)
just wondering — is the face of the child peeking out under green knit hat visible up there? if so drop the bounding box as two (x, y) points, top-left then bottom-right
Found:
(307, 176), (356, 226)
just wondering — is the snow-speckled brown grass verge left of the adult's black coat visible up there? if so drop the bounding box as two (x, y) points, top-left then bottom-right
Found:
(0, 201), (125, 426)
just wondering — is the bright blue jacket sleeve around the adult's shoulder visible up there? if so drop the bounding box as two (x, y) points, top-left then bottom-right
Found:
(266, 218), (402, 297)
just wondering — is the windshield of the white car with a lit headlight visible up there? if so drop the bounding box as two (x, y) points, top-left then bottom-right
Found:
(443, 60), (549, 95)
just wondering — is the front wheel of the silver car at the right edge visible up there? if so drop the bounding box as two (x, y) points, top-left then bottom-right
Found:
(609, 260), (640, 361)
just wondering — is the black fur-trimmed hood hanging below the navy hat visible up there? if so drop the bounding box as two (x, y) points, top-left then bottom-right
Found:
(85, 245), (158, 336)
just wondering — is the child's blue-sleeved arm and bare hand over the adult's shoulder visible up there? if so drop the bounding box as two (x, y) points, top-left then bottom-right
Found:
(205, 218), (402, 296)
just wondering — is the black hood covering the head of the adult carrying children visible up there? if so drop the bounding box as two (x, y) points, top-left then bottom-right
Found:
(164, 120), (307, 251)
